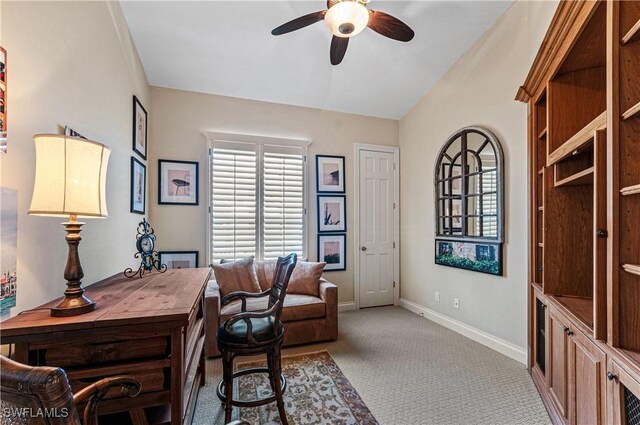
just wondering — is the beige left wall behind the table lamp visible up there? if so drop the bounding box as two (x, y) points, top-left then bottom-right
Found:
(0, 1), (149, 315)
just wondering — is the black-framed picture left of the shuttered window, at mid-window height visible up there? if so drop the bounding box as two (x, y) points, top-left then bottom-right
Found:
(158, 159), (200, 205)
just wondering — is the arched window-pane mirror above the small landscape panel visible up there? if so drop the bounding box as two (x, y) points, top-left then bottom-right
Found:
(434, 127), (503, 242)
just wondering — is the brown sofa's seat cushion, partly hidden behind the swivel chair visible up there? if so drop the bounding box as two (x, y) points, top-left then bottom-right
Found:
(220, 294), (326, 324)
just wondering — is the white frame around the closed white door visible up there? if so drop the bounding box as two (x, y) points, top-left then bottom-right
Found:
(353, 143), (400, 309)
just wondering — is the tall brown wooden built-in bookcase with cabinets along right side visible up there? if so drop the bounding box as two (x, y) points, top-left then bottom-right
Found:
(516, 0), (640, 424)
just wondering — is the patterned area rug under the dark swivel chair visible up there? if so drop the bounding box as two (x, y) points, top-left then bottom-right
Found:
(234, 351), (378, 425)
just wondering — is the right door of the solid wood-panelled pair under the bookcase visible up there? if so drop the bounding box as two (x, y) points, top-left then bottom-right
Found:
(568, 326), (607, 425)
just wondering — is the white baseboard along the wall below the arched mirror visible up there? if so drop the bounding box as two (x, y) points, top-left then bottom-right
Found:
(400, 298), (527, 365)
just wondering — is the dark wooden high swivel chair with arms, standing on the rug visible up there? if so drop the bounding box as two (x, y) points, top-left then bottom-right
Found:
(216, 254), (298, 425)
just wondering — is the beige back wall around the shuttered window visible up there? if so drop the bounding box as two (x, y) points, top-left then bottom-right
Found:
(149, 87), (398, 302)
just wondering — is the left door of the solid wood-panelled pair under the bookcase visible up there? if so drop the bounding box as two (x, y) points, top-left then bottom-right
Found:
(547, 308), (569, 422)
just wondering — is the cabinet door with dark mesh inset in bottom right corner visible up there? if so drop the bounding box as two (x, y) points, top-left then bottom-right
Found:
(607, 360), (640, 424)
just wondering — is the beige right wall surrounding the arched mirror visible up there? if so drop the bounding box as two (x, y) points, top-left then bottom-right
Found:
(400, 1), (557, 347)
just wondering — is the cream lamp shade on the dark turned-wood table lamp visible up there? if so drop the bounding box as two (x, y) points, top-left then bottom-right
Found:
(29, 134), (111, 217)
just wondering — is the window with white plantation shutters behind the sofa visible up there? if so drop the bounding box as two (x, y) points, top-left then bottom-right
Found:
(210, 137), (306, 263)
